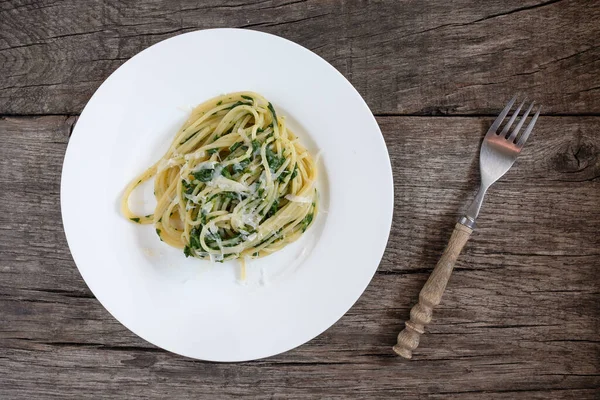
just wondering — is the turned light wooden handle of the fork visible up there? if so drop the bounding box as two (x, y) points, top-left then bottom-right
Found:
(393, 223), (473, 359)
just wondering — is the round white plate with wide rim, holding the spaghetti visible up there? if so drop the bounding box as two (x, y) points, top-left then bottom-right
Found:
(61, 29), (393, 361)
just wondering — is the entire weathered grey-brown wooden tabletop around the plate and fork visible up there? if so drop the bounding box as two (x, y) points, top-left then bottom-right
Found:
(0, 0), (600, 399)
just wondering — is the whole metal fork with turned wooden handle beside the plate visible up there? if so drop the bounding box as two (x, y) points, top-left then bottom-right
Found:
(393, 96), (540, 359)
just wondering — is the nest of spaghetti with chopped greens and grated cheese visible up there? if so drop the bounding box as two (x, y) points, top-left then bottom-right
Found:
(121, 92), (318, 265)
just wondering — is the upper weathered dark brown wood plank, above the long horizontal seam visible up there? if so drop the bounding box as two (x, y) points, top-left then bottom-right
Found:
(0, 0), (600, 115)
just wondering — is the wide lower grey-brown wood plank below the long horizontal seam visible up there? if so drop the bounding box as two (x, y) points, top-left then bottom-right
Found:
(0, 116), (600, 399)
